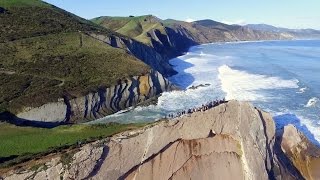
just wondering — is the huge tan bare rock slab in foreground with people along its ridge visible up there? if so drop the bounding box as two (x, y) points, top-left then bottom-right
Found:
(2, 101), (319, 180)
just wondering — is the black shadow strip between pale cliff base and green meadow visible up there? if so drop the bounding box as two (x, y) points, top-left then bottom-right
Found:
(0, 111), (66, 128)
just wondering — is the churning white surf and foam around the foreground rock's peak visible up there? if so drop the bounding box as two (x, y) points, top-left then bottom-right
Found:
(92, 42), (320, 145)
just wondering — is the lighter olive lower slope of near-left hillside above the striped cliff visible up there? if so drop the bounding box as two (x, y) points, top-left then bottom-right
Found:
(0, 32), (149, 113)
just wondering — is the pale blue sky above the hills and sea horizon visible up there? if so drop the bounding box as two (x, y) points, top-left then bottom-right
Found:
(45, 0), (320, 29)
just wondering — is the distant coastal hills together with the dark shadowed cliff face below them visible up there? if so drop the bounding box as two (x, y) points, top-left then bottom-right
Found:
(90, 15), (287, 79)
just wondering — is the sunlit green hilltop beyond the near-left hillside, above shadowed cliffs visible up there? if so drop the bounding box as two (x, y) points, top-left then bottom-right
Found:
(92, 15), (166, 45)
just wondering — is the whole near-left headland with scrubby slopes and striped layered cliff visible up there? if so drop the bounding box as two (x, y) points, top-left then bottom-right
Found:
(0, 0), (175, 124)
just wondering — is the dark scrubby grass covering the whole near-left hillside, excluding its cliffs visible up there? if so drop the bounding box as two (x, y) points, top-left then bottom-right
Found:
(0, 0), (149, 113)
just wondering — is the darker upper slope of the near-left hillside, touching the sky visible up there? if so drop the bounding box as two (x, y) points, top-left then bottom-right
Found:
(0, 0), (114, 42)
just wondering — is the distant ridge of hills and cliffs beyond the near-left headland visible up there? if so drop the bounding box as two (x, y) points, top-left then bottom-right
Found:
(92, 15), (287, 64)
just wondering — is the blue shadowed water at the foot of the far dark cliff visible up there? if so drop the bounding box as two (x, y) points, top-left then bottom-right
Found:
(169, 58), (195, 89)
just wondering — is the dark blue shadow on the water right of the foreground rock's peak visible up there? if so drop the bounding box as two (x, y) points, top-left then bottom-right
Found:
(273, 114), (320, 147)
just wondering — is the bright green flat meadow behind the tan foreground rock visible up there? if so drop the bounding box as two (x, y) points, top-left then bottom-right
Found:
(0, 123), (146, 165)
